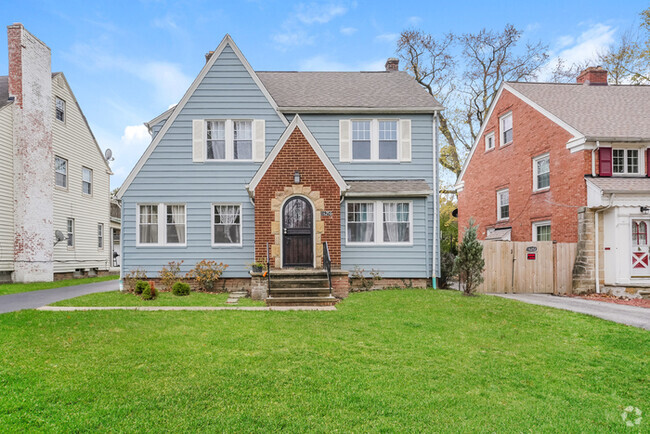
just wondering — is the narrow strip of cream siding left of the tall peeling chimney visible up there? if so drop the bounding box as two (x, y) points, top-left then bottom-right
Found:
(0, 104), (14, 271)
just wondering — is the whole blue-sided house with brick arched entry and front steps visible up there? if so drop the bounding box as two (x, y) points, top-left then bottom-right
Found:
(118, 35), (442, 305)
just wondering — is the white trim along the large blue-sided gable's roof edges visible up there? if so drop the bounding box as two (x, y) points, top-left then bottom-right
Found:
(117, 34), (289, 199)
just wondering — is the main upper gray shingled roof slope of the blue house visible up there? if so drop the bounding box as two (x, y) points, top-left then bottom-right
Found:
(257, 71), (442, 110)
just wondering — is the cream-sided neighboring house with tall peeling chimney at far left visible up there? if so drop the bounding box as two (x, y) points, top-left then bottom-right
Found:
(0, 24), (111, 282)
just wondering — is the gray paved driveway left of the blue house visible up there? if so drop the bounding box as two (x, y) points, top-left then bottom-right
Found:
(0, 280), (120, 313)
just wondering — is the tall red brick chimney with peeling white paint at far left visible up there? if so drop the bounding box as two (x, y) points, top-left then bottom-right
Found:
(7, 24), (54, 282)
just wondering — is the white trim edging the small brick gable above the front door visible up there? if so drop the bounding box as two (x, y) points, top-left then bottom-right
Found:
(246, 114), (349, 196)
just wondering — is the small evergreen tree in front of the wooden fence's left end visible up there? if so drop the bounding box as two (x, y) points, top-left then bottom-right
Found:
(454, 220), (485, 295)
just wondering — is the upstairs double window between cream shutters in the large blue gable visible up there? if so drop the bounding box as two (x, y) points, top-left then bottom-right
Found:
(205, 119), (253, 161)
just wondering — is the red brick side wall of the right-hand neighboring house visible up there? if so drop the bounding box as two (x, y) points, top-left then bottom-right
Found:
(458, 90), (598, 242)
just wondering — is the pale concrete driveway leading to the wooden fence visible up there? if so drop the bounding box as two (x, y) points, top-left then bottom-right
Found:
(490, 294), (650, 330)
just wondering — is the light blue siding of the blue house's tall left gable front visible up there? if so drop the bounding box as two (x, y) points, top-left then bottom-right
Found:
(122, 46), (285, 277)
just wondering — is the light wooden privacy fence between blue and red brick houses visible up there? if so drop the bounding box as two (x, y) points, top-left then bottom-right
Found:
(477, 241), (577, 294)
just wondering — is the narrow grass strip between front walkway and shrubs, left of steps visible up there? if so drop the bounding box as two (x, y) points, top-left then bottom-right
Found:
(52, 291), (266, 307)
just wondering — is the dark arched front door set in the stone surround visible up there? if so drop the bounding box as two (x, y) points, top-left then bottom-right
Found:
(282, 196), (314, 267)
